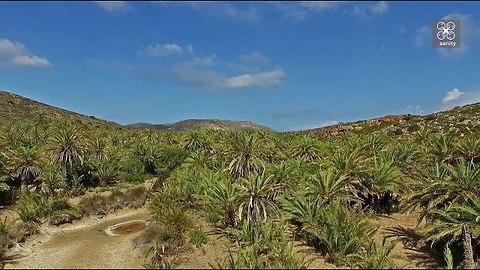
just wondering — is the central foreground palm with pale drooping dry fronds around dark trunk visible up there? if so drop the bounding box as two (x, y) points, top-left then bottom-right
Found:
(238, 171), (281, 222)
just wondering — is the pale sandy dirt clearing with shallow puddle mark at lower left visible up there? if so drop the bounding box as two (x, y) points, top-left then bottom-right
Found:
(5, 208), (148, 269)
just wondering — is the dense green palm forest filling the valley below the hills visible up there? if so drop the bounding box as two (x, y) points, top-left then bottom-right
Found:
(0, 108), (480, 268)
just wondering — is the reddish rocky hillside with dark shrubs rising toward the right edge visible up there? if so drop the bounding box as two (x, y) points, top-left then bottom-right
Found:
(299, 103), (480, 138)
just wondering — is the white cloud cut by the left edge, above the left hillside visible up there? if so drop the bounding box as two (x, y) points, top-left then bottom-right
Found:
(0, 39), (52, 67)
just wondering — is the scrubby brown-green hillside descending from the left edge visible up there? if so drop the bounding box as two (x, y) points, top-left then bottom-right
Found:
(0, 91), (121, 127)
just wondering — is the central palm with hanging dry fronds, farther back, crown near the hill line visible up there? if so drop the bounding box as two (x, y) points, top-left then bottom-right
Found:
(228, 132), (263, 178)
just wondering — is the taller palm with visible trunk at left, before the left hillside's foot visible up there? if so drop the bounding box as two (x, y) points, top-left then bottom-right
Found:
(52, 127), (83, 189)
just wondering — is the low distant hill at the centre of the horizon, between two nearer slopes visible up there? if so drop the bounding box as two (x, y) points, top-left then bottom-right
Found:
(127, 119), (270, 131)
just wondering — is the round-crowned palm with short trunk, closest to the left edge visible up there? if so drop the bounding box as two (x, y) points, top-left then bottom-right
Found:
(10, 146), (42, 193)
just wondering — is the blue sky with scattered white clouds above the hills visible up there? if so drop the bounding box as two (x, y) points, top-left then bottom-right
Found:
(0, 1), (480, 131)
